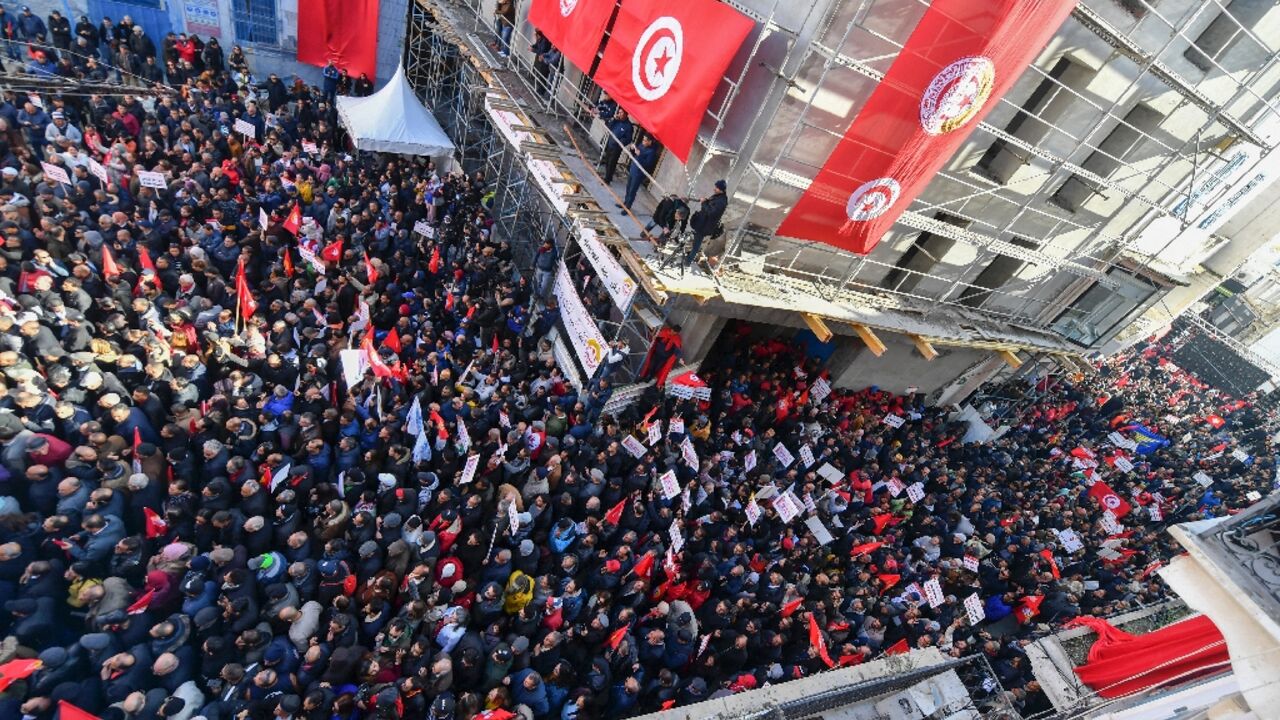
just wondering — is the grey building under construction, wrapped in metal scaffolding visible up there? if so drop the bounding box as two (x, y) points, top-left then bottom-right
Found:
(404, 0), (1280, 402)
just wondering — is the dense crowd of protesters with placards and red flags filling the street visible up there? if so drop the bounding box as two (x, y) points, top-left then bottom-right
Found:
(0, 9), (1275, 720)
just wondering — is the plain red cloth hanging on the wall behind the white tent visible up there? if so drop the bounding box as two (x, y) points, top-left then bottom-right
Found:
(298, 0), (378, 79)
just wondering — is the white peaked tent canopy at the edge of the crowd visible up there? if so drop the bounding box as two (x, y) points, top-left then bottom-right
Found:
(338, 65), (454, 158)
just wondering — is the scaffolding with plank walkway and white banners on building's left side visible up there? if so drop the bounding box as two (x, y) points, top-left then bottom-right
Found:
(404, 0), (666, 389)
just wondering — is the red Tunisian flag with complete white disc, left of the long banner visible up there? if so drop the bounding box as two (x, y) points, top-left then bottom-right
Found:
(593, 0), (755, 163)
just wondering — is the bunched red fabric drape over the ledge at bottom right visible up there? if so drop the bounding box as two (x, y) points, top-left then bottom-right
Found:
(1068, 615), (1230, 698)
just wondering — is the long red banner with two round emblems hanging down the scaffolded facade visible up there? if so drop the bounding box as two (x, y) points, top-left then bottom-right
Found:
(773, 0), (1075, 255)
